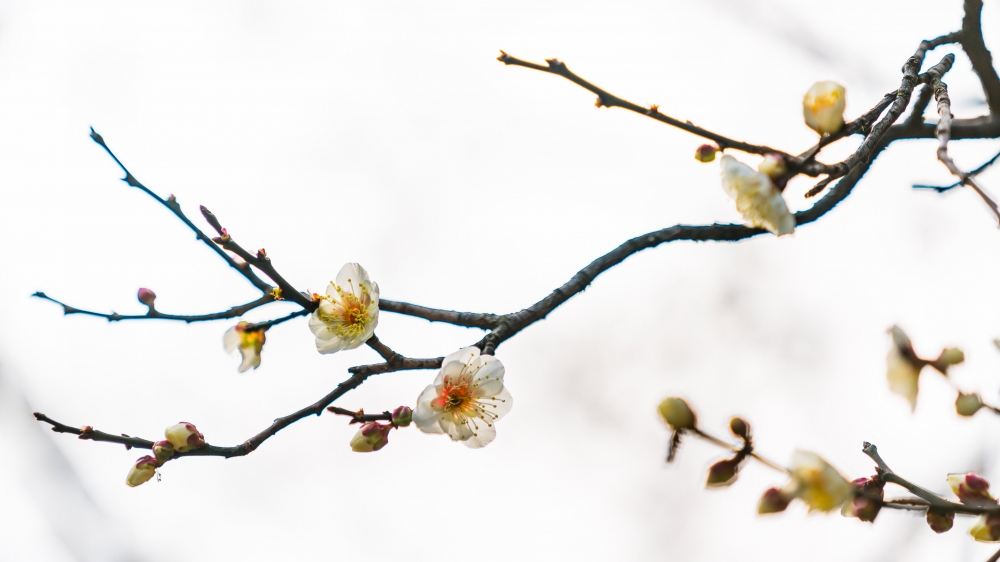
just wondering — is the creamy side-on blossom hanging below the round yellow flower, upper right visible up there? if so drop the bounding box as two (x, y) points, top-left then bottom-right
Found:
(719, 154), (795, 236)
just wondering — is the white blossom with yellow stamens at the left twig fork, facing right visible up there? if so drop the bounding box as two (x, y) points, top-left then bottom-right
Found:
(309, 263), (378, 354)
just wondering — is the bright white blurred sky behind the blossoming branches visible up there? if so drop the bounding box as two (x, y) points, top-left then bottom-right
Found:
(0, 0), (1000, 562)
